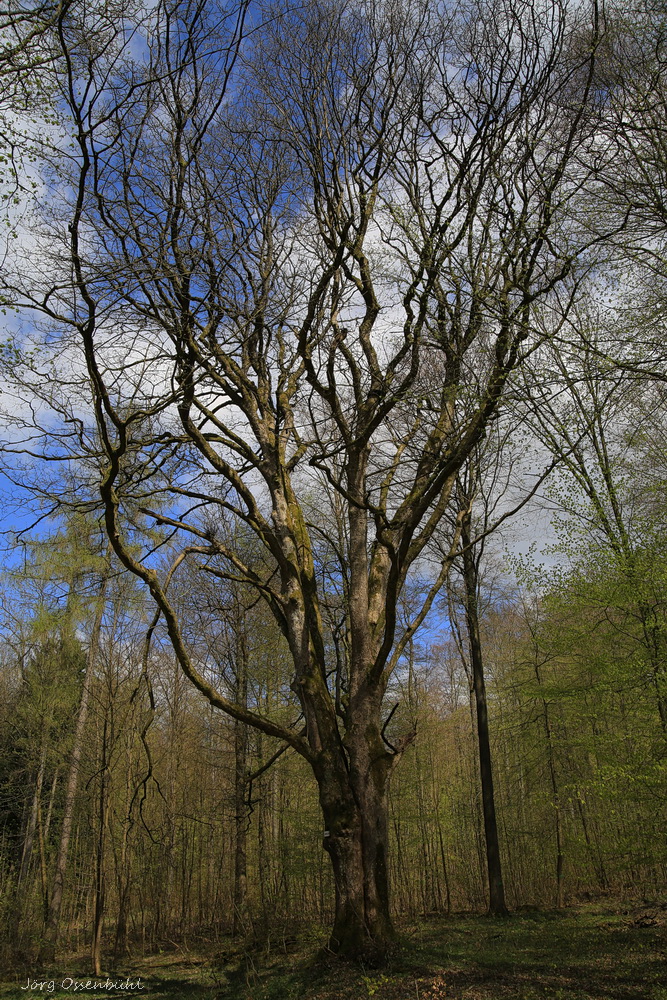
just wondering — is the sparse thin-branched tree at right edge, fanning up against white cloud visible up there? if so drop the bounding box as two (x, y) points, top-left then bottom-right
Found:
(528, 324), (667, 730)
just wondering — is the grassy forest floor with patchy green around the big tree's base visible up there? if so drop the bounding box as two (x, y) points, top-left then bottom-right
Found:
(0, 904), (667, 1000)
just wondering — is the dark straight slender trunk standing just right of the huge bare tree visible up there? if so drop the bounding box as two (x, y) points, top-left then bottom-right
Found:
(461, 515), (507, 917)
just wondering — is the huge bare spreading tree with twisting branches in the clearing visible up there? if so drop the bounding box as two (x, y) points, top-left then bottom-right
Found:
(2, 0), (612, 957)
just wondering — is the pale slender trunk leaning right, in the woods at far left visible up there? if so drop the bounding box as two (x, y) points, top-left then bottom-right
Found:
(40, 569), (109, 961)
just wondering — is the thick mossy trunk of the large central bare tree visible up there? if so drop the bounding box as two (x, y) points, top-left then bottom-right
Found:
(308, 456), (397, 964)
